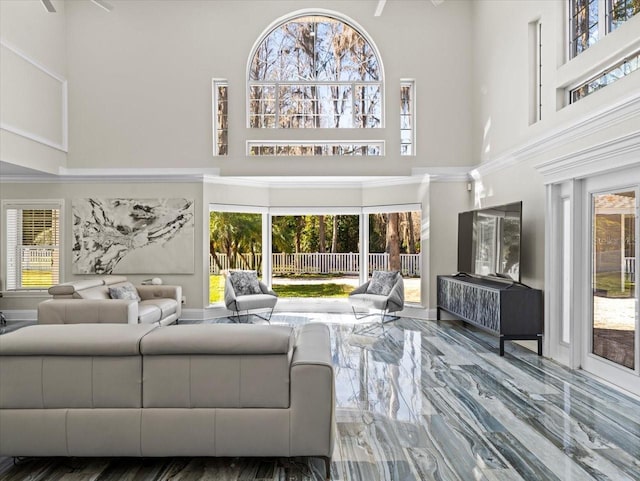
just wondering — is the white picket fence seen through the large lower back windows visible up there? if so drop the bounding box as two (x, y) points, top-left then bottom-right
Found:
(209, 252), (420, 277)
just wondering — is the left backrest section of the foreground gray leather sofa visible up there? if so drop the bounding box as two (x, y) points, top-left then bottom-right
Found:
(0, 324), (154, 409)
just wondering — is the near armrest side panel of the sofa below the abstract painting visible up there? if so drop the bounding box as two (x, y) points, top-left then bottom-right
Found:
(38, 299), (138, 324)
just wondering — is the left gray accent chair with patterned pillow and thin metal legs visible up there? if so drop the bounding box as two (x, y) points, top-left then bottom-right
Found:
(224, 270), (278, 323)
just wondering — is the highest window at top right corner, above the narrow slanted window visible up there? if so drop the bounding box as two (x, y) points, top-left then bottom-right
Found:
(569, 0), (640, 57)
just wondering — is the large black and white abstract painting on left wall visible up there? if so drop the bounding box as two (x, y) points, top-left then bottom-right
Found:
(72, 198), (195, 274)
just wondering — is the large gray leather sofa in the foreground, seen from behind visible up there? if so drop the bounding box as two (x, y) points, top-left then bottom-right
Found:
(0, 324), (334, 477)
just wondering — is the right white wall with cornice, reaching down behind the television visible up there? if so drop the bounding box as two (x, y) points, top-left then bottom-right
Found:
(470, 0), (640, 287)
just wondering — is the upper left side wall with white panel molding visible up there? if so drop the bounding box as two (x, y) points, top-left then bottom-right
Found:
(0, 0), (67, 173)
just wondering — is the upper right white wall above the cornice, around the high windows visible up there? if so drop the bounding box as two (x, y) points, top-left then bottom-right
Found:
(472, 0), (640, 164)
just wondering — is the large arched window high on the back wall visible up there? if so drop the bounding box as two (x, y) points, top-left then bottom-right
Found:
(248, 14), (384, 129)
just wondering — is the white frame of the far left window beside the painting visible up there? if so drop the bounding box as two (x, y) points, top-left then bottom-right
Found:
(0, 199), (66, 294)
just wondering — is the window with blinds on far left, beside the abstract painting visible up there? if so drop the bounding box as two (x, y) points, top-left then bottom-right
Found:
(4, 203), (61, 290)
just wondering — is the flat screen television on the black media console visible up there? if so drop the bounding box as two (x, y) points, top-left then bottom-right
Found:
(458, 202), (522, 282)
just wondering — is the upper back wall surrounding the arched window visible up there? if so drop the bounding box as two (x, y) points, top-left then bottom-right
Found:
(67, 0), (472, 175)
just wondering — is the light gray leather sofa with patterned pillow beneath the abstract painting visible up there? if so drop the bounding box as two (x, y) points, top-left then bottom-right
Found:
(38, 276), (182, 325)
